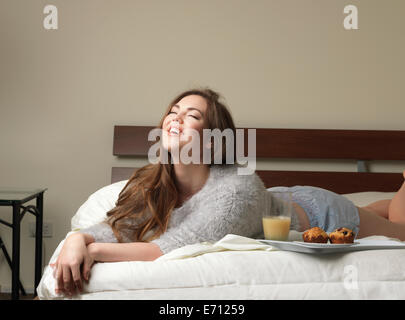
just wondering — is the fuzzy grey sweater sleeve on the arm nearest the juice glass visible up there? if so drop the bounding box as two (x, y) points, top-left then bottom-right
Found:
(152, 174), (268, 253)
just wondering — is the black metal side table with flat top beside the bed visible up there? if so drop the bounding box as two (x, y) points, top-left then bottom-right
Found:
(0, 188), (47, 300)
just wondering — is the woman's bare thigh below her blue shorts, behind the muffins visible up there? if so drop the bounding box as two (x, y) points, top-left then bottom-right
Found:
(357, 208), (405, 241)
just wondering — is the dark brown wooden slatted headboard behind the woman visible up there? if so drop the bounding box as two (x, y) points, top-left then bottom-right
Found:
(111, 126), (405, 194)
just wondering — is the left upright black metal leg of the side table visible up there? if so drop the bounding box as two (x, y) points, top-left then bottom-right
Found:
(11, 203), (21, 300)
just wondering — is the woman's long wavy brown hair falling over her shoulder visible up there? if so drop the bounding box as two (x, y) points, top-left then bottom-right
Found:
(107, 88), (236, 242)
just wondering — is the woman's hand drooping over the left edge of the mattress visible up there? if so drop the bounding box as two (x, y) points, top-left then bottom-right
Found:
(51, 233), (94, 295)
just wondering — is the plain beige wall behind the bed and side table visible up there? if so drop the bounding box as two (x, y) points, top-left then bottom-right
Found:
(0, 0), (405, 290)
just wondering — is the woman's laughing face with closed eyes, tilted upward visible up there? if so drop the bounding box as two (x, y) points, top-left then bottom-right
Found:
(162, 95), (207, 158)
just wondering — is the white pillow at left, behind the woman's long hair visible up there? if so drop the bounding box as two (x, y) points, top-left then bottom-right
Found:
(71, 180), (128, 231)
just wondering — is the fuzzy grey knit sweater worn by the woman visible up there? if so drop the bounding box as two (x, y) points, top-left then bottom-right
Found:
(80, 165), (297, 253)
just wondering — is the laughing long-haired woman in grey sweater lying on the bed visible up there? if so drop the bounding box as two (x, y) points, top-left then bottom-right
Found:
(52, 89), (405, 295)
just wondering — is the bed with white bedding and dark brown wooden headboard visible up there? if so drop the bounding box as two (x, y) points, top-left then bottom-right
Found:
(37, 126), (405, 300)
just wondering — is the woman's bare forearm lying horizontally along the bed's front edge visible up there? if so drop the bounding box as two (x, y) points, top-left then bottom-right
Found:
(87, 242), (163, 262)
